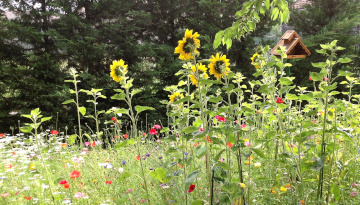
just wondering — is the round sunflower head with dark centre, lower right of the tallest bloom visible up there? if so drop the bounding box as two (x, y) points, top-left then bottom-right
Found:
(208, 53), (230, 79)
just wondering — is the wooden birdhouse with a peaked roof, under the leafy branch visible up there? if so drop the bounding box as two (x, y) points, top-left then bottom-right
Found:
(270, 30), (311, 59)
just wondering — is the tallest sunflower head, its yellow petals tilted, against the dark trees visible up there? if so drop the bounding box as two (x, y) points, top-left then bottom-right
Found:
(174, 29), (200, 60)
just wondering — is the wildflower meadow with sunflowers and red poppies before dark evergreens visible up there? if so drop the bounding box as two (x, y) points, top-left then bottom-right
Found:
(0, 6), (360, 205)
